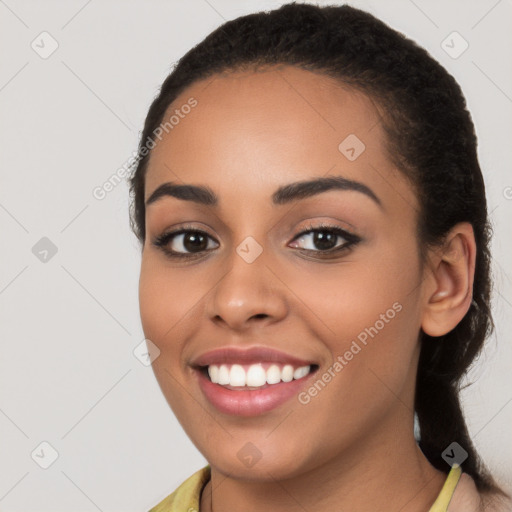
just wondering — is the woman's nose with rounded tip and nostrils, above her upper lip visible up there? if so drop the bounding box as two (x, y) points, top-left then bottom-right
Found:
(206, 245), (288, 332)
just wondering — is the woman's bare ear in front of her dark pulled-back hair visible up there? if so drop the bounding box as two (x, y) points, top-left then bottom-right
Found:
(421, 222), (476, 336)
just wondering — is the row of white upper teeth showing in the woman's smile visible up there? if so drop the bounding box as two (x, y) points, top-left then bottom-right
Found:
(208, 363), (311, 387)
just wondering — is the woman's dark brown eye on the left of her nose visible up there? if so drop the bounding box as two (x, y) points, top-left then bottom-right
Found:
(153, 226), (218, 258)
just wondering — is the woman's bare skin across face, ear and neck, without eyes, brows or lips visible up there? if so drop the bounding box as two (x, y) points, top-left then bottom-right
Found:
(140, 66), (475, 512)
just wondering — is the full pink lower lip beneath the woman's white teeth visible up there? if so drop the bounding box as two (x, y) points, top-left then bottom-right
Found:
(195, 369), (316, 416)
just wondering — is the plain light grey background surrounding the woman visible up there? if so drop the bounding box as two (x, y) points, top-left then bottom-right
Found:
(0, 0), (512, 512)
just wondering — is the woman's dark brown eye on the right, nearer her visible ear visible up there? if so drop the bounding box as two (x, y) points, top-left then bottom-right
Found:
(292, 224), (360, 254)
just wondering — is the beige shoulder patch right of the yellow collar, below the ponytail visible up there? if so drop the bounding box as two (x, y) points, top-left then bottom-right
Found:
(447, 473), (512, 512)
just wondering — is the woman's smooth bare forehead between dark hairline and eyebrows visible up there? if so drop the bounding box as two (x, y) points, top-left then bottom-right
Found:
(145, 66), (414, 214)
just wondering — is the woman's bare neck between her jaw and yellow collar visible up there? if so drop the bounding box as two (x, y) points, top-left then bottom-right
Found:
(200, 412), (446, 512)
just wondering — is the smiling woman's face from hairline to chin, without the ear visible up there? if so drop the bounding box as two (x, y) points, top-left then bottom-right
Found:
(140, 66), (423, 480)
